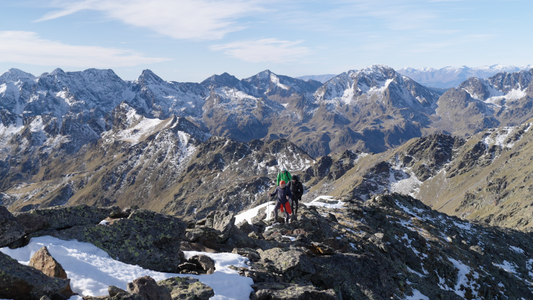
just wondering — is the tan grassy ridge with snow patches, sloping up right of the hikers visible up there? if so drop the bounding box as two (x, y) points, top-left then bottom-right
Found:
(302, 122), (533, 232)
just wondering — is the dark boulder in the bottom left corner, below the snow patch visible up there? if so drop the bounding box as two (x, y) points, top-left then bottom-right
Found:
(0, 252), (72, 300)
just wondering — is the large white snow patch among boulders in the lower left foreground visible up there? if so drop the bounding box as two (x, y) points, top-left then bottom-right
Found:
(0, 236), (253, 300)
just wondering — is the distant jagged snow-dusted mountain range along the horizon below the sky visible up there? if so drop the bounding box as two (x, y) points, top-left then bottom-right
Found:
(0, 65), (531, 157)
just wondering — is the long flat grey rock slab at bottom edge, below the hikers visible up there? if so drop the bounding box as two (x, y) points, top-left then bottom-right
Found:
(250, 282), (337, 300)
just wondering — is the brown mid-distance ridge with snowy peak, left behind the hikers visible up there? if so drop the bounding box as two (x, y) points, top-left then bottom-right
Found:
(0, 102), (314, 219)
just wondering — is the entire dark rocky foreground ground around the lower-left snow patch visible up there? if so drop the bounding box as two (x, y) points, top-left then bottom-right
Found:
(0, 194), (533, 300)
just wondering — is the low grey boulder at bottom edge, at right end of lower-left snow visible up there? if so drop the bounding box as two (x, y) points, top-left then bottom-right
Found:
(157, 277), (215, 300)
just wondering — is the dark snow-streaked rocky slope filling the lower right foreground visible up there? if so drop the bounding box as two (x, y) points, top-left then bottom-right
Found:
(233, 194), (533, 299)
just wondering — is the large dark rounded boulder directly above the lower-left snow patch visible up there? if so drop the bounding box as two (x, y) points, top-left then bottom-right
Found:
(50, 209), (187, 273)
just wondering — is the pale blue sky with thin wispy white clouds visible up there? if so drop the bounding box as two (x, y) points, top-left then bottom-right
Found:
(0, 0), (533, 82)
